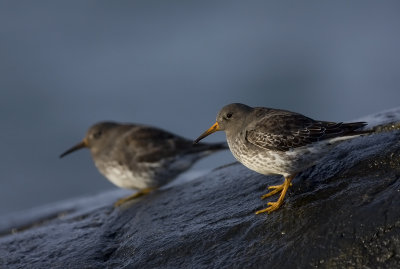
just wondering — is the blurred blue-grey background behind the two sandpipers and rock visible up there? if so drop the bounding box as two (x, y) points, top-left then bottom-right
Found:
(0, 0), (400, 215)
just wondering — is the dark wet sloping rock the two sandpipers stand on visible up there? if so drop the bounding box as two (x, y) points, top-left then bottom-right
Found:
(0, 109), (400, 268)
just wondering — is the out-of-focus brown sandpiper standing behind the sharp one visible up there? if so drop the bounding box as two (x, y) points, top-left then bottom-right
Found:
(60, 122), (228, 206)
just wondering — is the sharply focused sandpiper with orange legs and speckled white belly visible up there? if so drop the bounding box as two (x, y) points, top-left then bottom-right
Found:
(194, 103), (370, 214)
